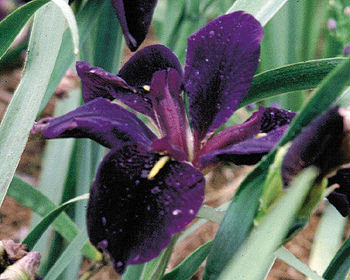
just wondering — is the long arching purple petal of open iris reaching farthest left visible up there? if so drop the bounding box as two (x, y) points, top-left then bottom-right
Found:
(33, 97), (156, 148)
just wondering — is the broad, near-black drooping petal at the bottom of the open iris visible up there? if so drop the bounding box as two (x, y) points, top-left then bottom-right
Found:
(87, 145), (204, 273)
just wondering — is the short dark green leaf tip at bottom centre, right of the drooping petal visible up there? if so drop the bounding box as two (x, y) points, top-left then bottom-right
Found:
(162, 241), (212, 280)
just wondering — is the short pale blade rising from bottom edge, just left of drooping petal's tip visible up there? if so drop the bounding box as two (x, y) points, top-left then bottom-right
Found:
(44, 229), (89, 280)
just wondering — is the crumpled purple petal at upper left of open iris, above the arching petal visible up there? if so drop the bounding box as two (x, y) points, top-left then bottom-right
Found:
(77, 61), (154, 118)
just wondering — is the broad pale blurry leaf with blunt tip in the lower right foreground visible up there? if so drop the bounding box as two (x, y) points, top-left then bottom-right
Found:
(219, 167), (318, 280)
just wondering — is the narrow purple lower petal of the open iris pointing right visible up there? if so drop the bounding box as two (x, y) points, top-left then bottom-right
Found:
(201, 125), (288, 168)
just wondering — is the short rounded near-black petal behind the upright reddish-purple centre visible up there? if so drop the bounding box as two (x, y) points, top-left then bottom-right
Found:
(118, 45), (182, 88)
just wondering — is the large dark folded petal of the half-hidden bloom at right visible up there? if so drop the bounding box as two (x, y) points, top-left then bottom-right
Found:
(282, 107), (347, 186)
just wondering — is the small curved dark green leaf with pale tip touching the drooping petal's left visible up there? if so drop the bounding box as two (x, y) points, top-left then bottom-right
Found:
(22, 194), (89, 250)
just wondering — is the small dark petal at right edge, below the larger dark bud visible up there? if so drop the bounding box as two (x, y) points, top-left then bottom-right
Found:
(327, 168), (350, 217)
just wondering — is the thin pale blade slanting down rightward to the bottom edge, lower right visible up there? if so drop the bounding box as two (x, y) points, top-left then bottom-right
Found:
(275, 247), (323, 280)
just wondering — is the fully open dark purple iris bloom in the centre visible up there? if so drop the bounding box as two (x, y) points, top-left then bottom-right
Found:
(34, 12), (295, 273)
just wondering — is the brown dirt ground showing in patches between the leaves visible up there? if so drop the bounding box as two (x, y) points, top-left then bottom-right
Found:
(0, 64), (344, 280)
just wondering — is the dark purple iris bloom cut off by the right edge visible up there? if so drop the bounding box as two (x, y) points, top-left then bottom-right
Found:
(282, 107), (350, 216)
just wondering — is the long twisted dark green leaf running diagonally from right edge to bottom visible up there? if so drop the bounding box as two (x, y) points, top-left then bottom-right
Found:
(204, 56), (350, 279)
